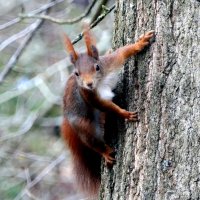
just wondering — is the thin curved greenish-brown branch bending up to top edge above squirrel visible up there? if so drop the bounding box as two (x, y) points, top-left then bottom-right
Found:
(19, 0), (97, 24)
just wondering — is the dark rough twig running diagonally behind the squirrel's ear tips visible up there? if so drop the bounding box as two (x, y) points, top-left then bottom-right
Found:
(72, 5), (115, 44)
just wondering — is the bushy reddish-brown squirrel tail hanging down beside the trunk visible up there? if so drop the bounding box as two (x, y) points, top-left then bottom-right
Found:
(62, 119), (101, 198)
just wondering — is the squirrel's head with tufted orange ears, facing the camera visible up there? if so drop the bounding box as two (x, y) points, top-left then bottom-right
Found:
(64, 27), (104, 90)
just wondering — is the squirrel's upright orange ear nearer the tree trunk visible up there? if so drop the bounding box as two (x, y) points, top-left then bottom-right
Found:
(83, 26), (99, 60)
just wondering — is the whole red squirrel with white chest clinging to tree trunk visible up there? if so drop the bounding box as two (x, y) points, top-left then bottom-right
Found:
(62, 28), (154, 195)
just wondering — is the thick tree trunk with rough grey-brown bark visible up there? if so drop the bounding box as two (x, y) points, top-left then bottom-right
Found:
(99, 0), (200, 200)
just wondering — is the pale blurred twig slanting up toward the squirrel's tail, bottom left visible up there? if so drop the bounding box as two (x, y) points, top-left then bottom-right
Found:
(14, 153), (66, 200)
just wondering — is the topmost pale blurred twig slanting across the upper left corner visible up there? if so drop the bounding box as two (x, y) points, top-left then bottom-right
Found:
(0, 0), (64, 31)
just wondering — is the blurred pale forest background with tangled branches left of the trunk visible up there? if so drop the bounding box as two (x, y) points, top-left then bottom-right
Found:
(0, 0), (114, 200)
